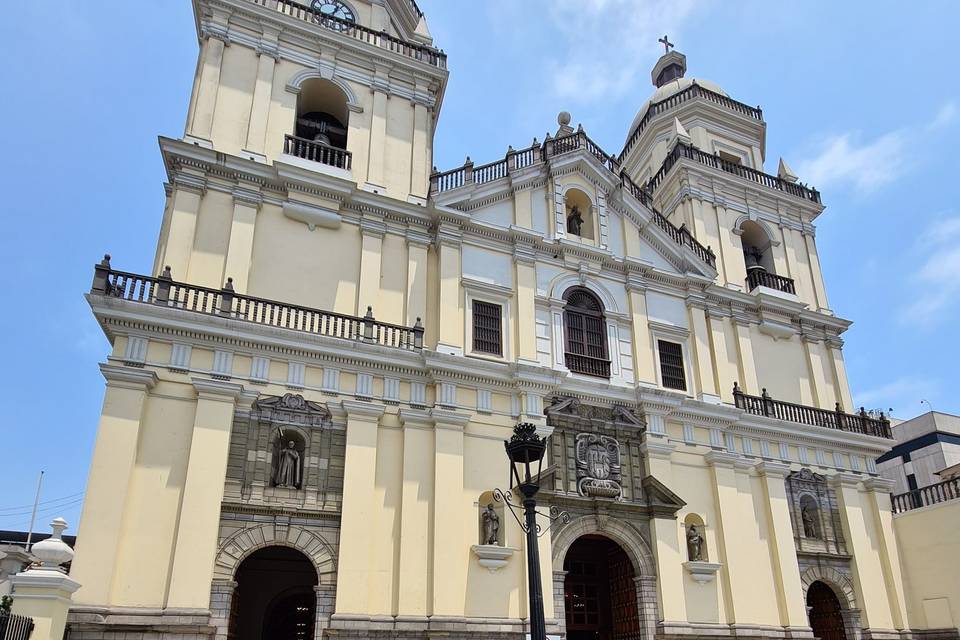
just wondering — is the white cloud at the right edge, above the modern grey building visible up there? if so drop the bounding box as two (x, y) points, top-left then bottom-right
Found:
(899, 215), (960, 327)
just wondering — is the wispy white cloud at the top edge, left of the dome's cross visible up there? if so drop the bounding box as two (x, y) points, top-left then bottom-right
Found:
(549, 0), (694, 103)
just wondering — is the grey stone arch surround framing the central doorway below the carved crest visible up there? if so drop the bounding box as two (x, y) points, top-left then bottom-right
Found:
(553, 515), (658, 640)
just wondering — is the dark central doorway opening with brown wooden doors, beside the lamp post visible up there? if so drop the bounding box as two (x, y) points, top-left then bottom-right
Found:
(563, 535), (642, 640)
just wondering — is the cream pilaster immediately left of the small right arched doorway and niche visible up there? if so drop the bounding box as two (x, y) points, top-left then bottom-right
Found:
(755, 460), (809, 629)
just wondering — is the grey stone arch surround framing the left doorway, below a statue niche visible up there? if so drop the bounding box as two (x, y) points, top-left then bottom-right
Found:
(210, 522), (337, 640)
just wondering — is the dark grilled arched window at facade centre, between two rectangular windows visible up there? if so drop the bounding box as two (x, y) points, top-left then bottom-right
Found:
(563, 287), (610, 378)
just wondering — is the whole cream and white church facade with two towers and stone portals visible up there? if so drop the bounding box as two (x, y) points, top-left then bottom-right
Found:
(68, 0), (913, 640)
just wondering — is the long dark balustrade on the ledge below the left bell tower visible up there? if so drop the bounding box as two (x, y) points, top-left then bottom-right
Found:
(90, 256), (423, 351)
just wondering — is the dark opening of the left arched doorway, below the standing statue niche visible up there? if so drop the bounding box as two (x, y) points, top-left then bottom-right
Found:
(229, 546), (317, 640)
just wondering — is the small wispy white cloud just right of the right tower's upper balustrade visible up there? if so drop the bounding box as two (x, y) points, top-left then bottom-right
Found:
(797, 130), (907, 193)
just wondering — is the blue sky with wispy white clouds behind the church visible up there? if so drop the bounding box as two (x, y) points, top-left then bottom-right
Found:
(0, 0), (960, 533)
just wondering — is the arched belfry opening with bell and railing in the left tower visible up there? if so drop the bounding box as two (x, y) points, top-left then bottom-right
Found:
(284, 78), (350, 169)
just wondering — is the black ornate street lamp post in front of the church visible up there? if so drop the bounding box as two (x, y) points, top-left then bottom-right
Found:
(503, 422), (547, 640)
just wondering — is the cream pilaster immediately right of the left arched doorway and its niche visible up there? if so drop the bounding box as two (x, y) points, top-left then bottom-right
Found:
(336, 400), (383, 615)
